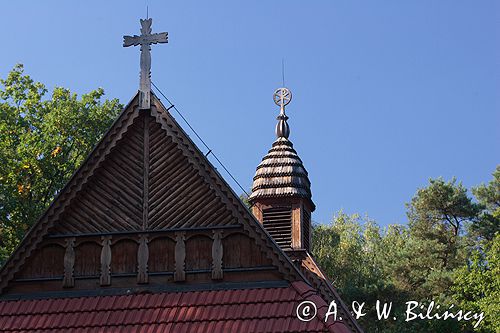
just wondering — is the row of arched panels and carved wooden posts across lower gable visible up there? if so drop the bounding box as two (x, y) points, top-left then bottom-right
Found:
(9, 225), (275, 288)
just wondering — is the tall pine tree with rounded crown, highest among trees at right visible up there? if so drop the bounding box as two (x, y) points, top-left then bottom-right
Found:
(394, 179), (480, 298)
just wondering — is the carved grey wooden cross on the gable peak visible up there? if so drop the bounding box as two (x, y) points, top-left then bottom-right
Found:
(123, 19), (168, 109)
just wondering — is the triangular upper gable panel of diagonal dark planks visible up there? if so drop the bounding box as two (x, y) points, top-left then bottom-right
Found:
(49, 107), (236, 235)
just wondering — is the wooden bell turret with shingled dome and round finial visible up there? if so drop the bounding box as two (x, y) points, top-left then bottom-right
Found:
(248, 88), (315, 252)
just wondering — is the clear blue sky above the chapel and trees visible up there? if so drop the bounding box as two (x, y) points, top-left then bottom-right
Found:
(0, 0), (500, 225)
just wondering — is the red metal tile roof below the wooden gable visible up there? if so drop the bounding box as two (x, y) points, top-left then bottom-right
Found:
(0, 282), (350, 333)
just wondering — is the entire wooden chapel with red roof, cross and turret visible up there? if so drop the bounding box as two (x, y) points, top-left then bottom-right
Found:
(0, 19), (363, 333)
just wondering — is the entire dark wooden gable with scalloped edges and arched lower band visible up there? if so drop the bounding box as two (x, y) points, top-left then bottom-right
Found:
(0, 92), (306, 298)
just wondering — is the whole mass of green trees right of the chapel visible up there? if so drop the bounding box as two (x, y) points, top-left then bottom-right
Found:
(313, 168), (500, 332)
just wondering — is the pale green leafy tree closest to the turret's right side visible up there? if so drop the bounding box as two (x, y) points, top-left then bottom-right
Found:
(313, 211), (394, 332)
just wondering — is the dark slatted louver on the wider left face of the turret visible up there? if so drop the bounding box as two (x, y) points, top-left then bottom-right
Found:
(262, 207), (292, 249)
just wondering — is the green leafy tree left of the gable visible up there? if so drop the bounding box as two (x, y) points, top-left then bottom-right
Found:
(0, 65), (122, 264)
